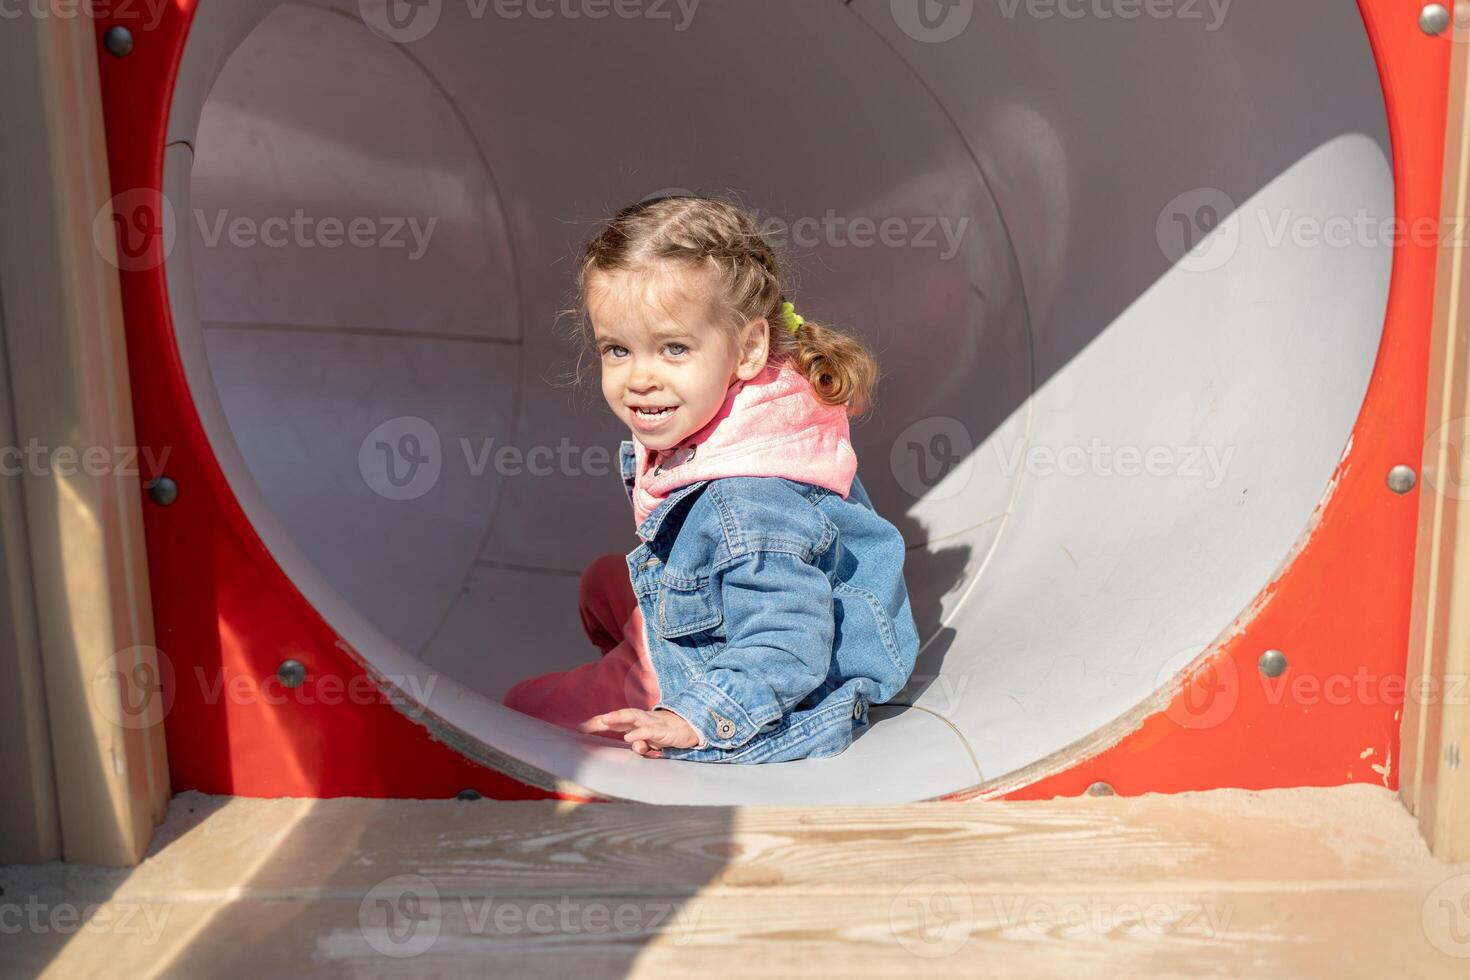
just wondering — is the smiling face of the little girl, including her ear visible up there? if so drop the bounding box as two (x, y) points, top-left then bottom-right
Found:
(587, 263), (769, 450)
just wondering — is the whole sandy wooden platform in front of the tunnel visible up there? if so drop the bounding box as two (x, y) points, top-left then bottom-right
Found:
(0, 786), (1470, 980)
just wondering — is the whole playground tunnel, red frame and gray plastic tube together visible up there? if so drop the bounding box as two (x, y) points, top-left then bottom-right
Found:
(98, 0), (1452, 804)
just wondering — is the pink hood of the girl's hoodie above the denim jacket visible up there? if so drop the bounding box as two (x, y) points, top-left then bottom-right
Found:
(632, 360), (857, 527)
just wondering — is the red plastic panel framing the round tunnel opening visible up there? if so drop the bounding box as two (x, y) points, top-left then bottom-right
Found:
(97, 0), (1449, 799)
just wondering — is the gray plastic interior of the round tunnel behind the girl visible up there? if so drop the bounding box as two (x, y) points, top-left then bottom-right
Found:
(166, 0), (1392, 802)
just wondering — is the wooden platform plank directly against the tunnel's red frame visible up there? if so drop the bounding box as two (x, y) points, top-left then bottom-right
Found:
(91, 786), (1427, 895)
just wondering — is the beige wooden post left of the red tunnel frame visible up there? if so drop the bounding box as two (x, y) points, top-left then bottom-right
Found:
(0, 16), (169, 865)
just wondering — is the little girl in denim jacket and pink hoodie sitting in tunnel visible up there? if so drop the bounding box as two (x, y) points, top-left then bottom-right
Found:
(504, 197), (919, 763)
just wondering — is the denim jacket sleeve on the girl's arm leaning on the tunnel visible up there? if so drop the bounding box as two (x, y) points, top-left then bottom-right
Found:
(656, 550), (835, 749)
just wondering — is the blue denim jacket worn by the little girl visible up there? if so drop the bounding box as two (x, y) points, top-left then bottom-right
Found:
(619, 441), (919, 763)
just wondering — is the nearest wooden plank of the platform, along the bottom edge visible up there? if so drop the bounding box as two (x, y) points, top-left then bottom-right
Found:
(12, 887), (1466, 980)
